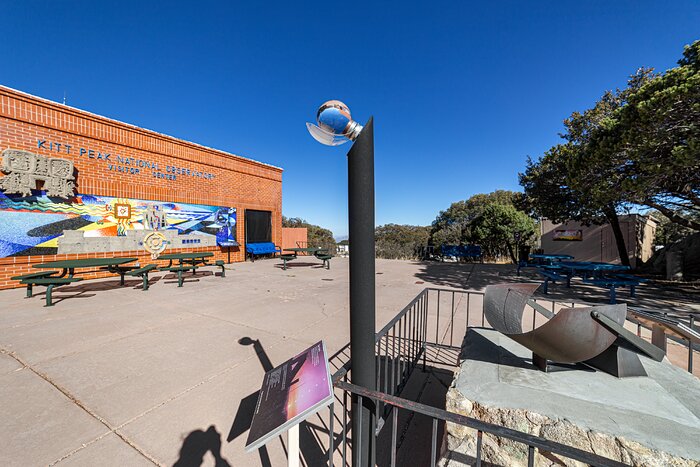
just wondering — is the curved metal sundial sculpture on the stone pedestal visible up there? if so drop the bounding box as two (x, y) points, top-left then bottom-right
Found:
(484, 284), (665, 377)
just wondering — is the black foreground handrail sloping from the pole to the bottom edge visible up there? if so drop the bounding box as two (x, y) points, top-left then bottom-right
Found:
(335, 381), (627, 467)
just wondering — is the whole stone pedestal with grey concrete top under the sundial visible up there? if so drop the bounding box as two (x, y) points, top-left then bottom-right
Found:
(440, 328), (700, 467)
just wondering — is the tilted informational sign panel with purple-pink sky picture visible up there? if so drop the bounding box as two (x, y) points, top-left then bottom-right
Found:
(246, 341), (333, 451)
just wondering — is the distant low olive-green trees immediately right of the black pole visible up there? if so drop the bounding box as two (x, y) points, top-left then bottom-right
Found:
(374, 224), (430, 259)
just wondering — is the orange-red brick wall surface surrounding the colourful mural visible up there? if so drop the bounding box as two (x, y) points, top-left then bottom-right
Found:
(0, 86), (282, 289)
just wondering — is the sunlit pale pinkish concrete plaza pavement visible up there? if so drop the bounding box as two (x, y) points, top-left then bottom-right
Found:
(0, 258), (700, 466)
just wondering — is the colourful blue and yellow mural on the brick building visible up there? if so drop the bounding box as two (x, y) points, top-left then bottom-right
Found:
(0, 192), (238, 257)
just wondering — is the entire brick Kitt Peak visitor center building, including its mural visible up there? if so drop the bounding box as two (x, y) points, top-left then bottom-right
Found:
(0, 86), (282, 289)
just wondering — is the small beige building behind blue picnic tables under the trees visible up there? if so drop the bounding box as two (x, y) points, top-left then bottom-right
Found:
(540, 214), (658, 268)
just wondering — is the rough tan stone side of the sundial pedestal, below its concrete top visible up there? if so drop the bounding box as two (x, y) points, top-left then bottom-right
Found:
(439, 372), (700, 467)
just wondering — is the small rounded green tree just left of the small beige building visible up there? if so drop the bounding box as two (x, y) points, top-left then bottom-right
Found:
(471, 203), (536, 263)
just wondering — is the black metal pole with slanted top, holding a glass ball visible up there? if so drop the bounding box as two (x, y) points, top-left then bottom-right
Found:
(348, 118), (376, 467)
